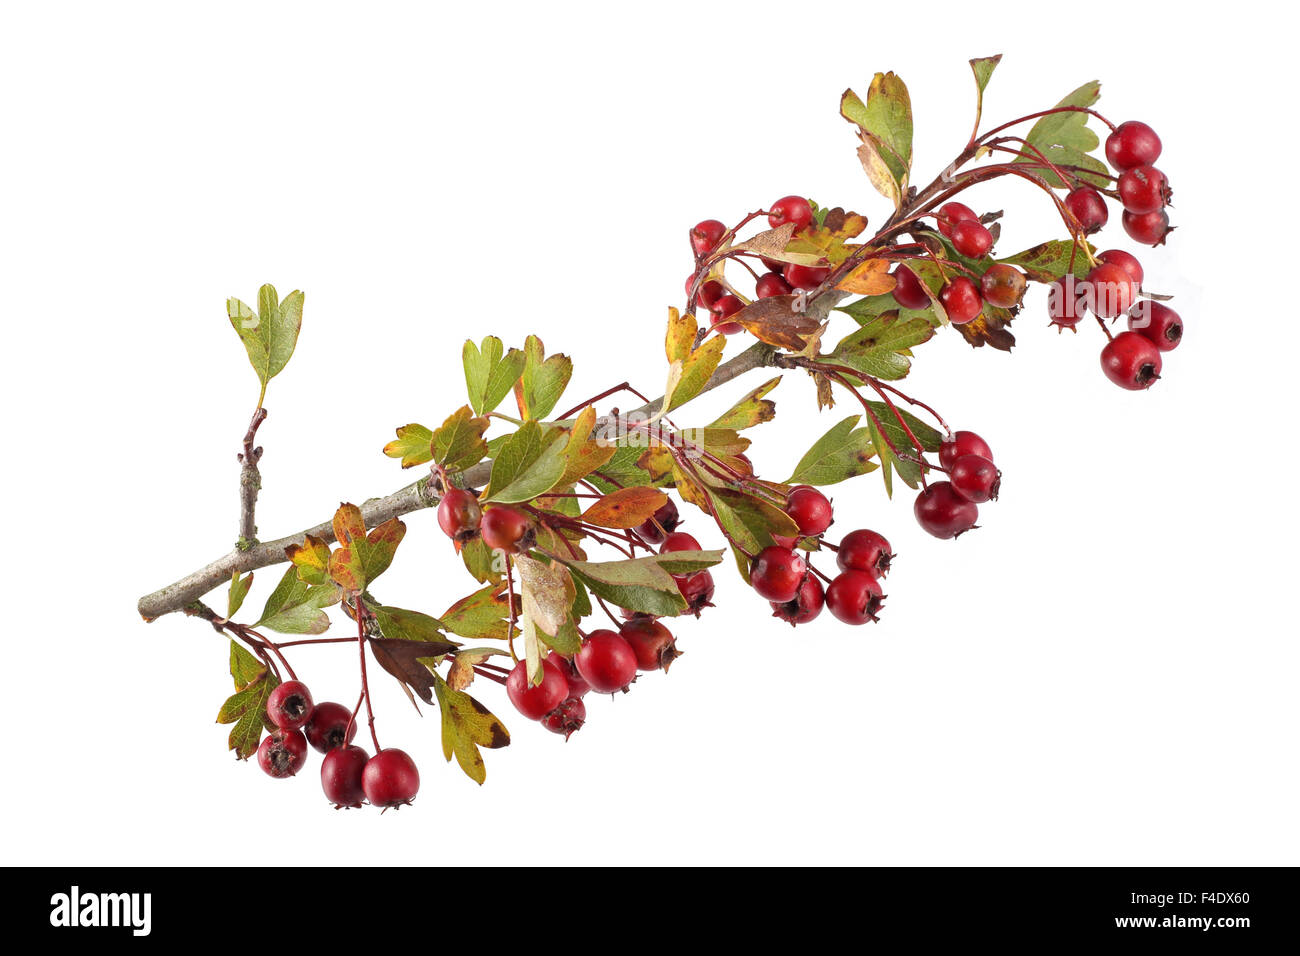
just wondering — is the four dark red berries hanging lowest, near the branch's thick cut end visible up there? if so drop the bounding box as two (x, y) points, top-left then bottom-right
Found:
(257, 680), (420, 809)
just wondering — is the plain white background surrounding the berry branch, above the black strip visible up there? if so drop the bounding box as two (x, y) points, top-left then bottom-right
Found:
(0, 3), (1300, 865)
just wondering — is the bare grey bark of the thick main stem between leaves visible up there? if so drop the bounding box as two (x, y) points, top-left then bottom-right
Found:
(137, 332), (821, 620)
